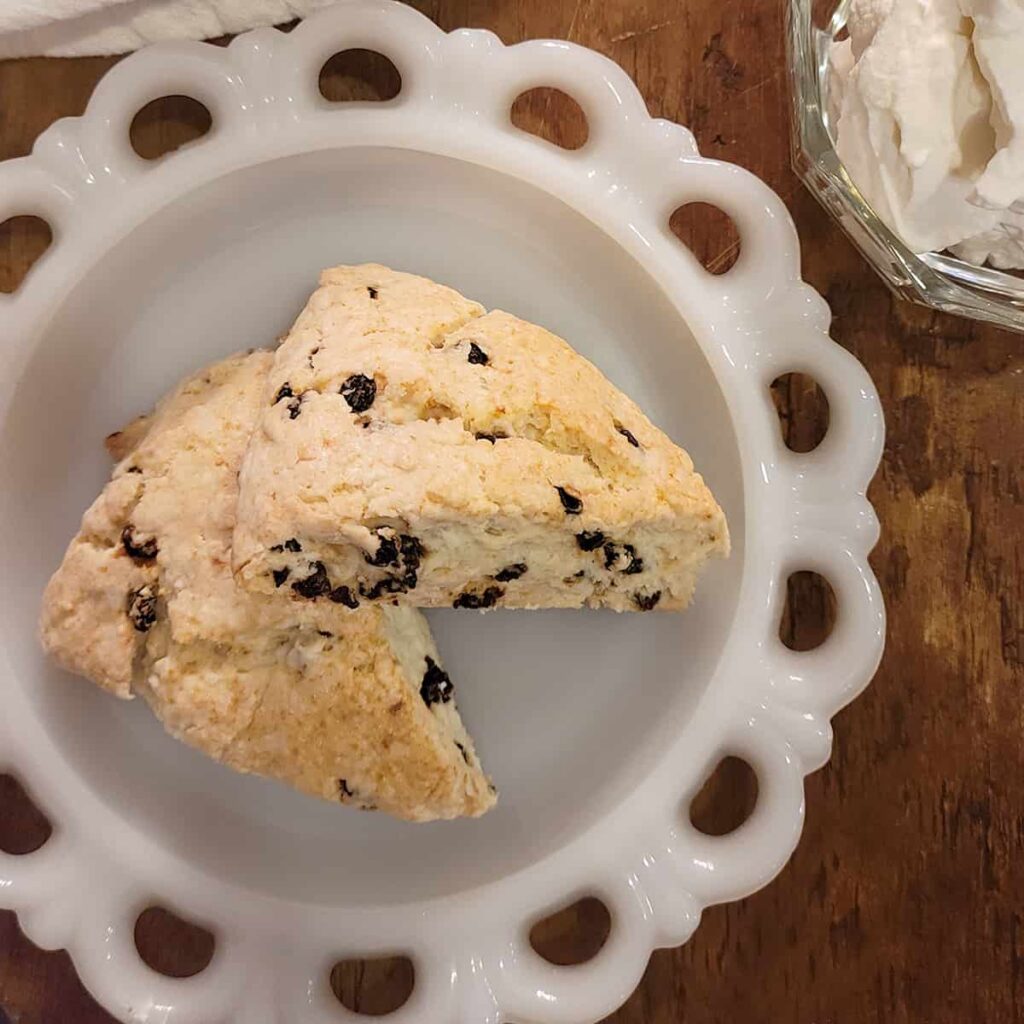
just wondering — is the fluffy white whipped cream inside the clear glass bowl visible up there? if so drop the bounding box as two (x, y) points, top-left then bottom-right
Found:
(828, 0), (1024, 269)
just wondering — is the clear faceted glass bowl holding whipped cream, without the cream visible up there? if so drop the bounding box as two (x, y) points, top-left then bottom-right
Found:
(786, 0), (1024, 332)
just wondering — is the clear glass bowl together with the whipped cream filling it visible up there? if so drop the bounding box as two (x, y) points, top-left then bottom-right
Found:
(788, 0), (1024, 330)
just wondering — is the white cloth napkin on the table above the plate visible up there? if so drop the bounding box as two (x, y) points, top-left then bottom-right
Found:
(0, 0), (331, 59)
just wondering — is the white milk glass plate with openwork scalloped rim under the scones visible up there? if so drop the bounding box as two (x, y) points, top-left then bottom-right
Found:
(0, 0), (884, 1024)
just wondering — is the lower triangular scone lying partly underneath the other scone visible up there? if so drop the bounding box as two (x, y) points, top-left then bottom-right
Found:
(41, 352), (495, 820)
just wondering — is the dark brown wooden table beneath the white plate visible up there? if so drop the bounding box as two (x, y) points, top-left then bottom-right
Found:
(0, 0), (1024, 1024)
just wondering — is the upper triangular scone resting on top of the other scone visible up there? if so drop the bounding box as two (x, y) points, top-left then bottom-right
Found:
(233, 264), (729, 610)
